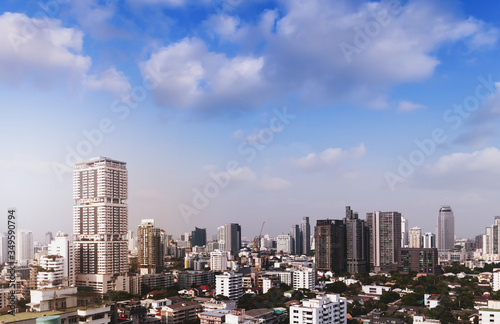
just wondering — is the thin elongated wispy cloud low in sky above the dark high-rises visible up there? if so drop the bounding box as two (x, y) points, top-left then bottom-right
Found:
(292, 143), (366, 170)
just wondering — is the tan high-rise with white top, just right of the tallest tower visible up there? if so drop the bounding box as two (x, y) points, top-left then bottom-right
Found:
(137, 219), (164, 275)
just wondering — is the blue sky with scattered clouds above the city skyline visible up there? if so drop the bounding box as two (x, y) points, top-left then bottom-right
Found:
(0, 0), (500, 239)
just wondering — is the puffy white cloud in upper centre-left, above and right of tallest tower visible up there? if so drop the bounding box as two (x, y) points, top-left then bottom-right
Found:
(141, 38), (266, 110)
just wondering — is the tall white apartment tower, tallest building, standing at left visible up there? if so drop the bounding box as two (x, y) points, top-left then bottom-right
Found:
(73, 157), (128, 293)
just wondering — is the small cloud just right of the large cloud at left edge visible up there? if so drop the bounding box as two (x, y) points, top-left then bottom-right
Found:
(87, 67), (131, 97)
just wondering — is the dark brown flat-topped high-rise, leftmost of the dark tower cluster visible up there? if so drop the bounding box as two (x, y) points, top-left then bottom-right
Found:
(314, 219), (347, 273)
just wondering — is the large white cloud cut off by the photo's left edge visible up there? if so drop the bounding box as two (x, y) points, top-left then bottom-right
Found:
(0, 12), (91, 87)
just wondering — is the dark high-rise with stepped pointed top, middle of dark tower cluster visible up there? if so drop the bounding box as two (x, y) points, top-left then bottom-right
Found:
(344, 206), (370, 273)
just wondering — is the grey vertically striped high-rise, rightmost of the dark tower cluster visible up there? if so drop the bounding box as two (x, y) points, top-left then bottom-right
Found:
(366, 211), (401, 271)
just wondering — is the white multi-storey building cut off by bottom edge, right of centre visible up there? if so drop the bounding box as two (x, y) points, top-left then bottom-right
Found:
(290, 295), (347, 324)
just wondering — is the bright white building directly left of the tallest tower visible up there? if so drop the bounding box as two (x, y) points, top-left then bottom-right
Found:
(48, 232), (75, 286)
